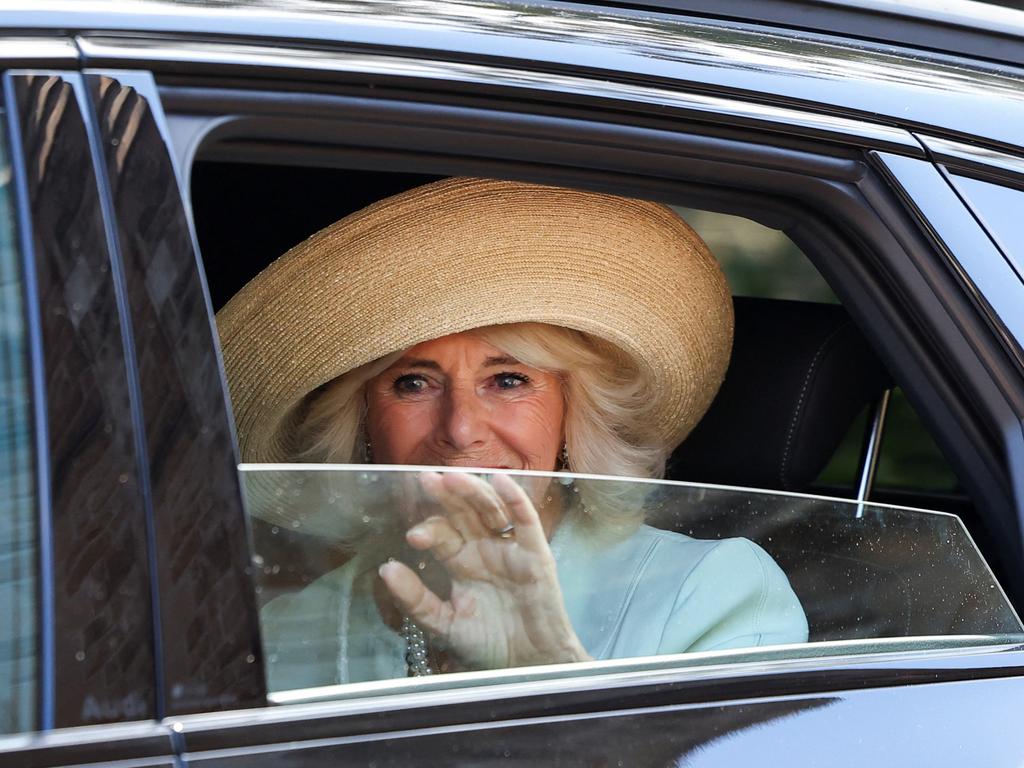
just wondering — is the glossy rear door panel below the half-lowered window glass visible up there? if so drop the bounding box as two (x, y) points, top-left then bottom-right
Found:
(167, 653), (1024, 768)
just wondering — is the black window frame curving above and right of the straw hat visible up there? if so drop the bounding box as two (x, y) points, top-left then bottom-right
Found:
(158, 74), (1024, 605)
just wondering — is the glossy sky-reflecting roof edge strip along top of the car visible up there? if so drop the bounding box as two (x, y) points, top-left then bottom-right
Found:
(6, 0), (1024, 145)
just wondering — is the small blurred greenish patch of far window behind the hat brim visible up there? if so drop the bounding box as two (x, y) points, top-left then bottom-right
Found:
(675, 207), (839, 303)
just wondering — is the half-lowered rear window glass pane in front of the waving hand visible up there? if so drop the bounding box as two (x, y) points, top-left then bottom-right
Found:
(243, 465), (1021, 691)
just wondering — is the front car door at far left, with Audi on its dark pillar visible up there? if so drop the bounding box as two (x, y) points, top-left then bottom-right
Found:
(0, 58), (172, 765)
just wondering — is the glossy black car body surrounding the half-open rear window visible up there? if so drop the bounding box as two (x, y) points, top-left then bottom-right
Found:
(0, 0), (1024, 768)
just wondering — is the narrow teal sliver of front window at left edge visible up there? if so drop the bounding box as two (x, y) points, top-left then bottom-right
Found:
(0, 120), (37, 733)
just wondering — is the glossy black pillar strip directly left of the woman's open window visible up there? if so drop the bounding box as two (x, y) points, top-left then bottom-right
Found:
(86, 75), (264, 715)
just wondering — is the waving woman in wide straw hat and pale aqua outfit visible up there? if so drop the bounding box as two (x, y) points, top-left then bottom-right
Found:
(217, 179), (807, 689)
